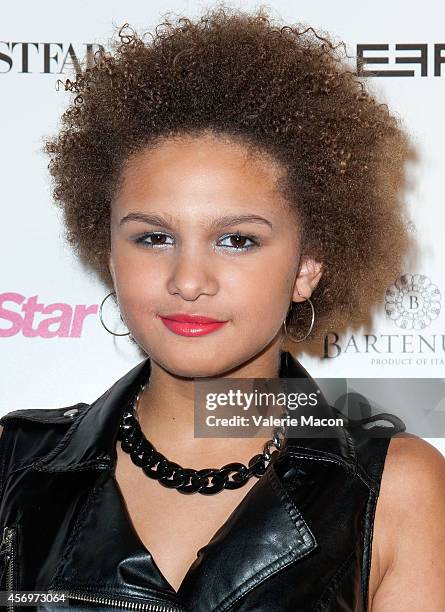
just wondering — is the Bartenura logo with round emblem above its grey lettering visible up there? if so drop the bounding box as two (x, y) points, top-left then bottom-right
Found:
(322, 273), (445, 366)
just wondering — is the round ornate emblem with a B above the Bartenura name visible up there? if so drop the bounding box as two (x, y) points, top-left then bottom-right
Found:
(385, 274), (441, 330)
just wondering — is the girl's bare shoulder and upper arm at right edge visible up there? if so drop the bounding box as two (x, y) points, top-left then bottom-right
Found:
(370, 433), (445, 612)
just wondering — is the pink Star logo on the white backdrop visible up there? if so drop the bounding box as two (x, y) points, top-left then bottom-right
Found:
(0, 291), (98, 339)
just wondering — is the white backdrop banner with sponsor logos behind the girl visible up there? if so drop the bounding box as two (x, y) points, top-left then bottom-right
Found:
(0, 0), (445, 453)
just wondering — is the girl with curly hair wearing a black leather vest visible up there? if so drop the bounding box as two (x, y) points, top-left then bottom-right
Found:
(0, 7), (445, 612)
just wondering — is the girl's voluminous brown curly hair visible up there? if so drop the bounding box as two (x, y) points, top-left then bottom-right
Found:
(45, 5), (415, 339)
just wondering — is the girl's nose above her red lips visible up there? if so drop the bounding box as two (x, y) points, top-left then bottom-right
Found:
(167, 247), (218, 301)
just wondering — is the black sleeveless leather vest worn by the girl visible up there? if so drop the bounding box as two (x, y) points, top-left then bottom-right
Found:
(0, 352), (397, 612)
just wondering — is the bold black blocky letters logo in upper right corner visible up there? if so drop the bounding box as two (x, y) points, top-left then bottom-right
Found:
(356, 43), (445, 77)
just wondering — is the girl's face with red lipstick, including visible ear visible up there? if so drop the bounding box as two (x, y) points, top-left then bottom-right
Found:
(109, 135), (319, 377)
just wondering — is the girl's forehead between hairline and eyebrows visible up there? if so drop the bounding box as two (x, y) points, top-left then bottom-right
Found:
(112, 135), (290, 213)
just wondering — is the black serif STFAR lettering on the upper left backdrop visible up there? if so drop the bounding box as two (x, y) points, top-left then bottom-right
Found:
(0, 41), (105, 74)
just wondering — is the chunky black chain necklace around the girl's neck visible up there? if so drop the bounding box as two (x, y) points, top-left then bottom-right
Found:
(118, 385), (284, 495)
